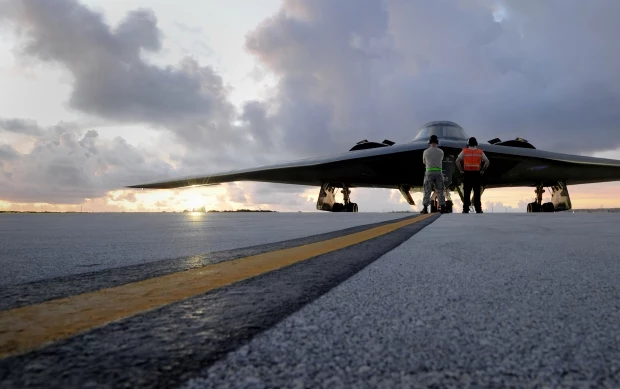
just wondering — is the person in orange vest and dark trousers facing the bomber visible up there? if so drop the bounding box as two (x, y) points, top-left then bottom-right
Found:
(456, 136), (490, 213)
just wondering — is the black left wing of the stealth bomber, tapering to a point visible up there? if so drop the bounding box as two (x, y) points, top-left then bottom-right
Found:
(129, 143), (428, 189)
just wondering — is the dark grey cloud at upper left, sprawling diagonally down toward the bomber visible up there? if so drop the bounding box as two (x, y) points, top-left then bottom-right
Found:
(1, 0), (251, 150)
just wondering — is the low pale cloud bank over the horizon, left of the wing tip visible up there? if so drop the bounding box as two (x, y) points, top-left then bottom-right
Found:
(0, 119), (172, 204)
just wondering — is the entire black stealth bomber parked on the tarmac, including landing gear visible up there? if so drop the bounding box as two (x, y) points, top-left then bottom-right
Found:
(129, 121), (620, 212)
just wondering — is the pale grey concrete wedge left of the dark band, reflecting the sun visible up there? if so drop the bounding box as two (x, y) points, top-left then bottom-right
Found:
(0, 212), (407, 285)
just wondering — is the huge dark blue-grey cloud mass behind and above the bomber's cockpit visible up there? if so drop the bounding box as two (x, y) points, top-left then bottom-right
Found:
(246, 0), (620, 154)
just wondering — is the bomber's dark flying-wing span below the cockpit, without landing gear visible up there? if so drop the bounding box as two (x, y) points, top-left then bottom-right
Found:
(130, 141), (620, 189)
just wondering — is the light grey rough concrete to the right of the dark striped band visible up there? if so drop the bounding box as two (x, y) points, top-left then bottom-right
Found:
(185, 213), (620, 388)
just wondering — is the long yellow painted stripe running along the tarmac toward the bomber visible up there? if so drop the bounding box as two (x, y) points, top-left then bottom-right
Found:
(0, 214), (432, 358)
